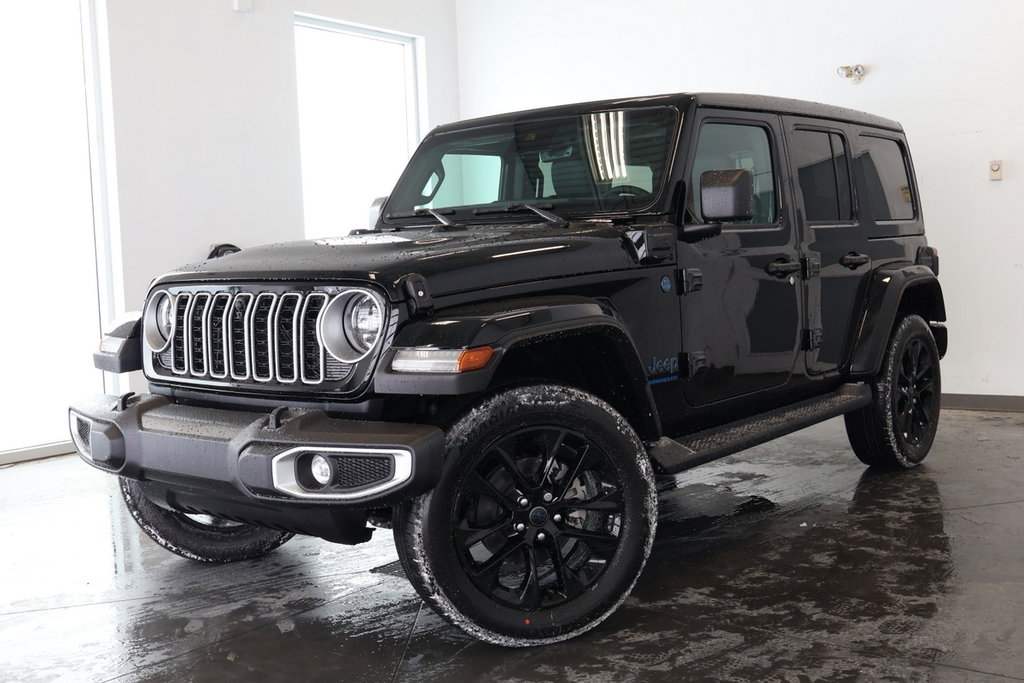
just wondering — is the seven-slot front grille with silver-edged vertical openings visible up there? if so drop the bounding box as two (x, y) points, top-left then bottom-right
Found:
(156, 292), (353, 384)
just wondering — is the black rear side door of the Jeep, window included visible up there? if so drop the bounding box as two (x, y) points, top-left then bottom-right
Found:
(783, 117), (871, 374)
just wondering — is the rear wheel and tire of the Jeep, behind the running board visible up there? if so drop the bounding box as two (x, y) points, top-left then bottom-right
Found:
(846, 315), (941, 469)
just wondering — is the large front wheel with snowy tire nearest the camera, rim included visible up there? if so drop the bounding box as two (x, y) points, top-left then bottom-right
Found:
(394, 385), (657, 647)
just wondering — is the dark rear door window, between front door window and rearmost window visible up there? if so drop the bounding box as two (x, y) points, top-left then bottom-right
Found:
(793, 130), (853, 223)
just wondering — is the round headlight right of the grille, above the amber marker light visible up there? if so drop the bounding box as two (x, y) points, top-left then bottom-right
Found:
(319, 290), (384, 362)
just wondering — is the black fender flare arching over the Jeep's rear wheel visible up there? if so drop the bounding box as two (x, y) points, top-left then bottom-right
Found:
(850, 264), (946, 376)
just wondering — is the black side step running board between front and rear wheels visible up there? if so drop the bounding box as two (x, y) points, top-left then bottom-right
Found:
(650, 384), (871, 474)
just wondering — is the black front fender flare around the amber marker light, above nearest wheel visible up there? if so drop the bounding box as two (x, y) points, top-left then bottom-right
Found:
(374, 296), (660, 438)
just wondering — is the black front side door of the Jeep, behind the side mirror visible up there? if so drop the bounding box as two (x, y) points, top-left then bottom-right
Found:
(679, 110), (803, 405)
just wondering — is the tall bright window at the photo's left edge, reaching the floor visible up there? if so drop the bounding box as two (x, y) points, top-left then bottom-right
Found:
(0, 0), (103, 462)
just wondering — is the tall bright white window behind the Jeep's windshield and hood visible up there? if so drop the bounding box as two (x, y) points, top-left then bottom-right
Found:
(295, 14), (423, 239)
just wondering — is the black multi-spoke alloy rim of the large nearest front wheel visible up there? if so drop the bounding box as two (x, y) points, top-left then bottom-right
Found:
(451, 425), (625, 610)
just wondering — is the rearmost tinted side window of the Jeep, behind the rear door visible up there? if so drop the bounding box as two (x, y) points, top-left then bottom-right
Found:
(857, 135), (913, 220)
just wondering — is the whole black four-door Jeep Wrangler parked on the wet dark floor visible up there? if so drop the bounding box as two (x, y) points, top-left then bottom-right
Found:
(70, 94), (946, 645)
